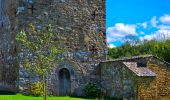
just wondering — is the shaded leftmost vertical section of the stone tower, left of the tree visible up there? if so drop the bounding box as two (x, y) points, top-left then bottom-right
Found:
(0, 0), (19, 91)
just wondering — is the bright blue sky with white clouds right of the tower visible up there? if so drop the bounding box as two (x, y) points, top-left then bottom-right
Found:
(106, 0), (170, 47)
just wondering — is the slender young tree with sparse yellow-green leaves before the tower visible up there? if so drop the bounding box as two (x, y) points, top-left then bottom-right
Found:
(16, 24), (63, 100)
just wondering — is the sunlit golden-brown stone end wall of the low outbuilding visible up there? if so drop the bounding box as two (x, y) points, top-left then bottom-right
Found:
(139, 58), (170, 100)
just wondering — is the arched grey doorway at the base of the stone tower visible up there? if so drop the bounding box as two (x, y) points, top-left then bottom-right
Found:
(59, 68), (71, 96)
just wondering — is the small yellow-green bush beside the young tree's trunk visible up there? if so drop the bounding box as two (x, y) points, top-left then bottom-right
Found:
(31, 81), (43, 96)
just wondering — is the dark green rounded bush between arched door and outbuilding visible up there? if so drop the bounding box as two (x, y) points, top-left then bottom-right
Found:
(83, 83), (101, 97)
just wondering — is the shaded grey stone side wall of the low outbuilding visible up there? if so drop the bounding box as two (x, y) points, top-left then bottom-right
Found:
(100, 62), (137, 99)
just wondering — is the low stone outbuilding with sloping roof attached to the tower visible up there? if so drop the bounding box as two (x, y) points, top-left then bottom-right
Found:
(97, 56), (170, 100)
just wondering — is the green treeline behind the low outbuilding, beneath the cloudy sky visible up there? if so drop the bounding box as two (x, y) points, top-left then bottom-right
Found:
(108, 39), (170, 63)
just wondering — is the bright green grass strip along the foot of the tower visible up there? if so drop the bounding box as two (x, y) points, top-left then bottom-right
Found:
(0, 94), (92, 100)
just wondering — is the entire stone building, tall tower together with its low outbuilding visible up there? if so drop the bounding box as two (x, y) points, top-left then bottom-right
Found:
(0, 0), (170, 100)
